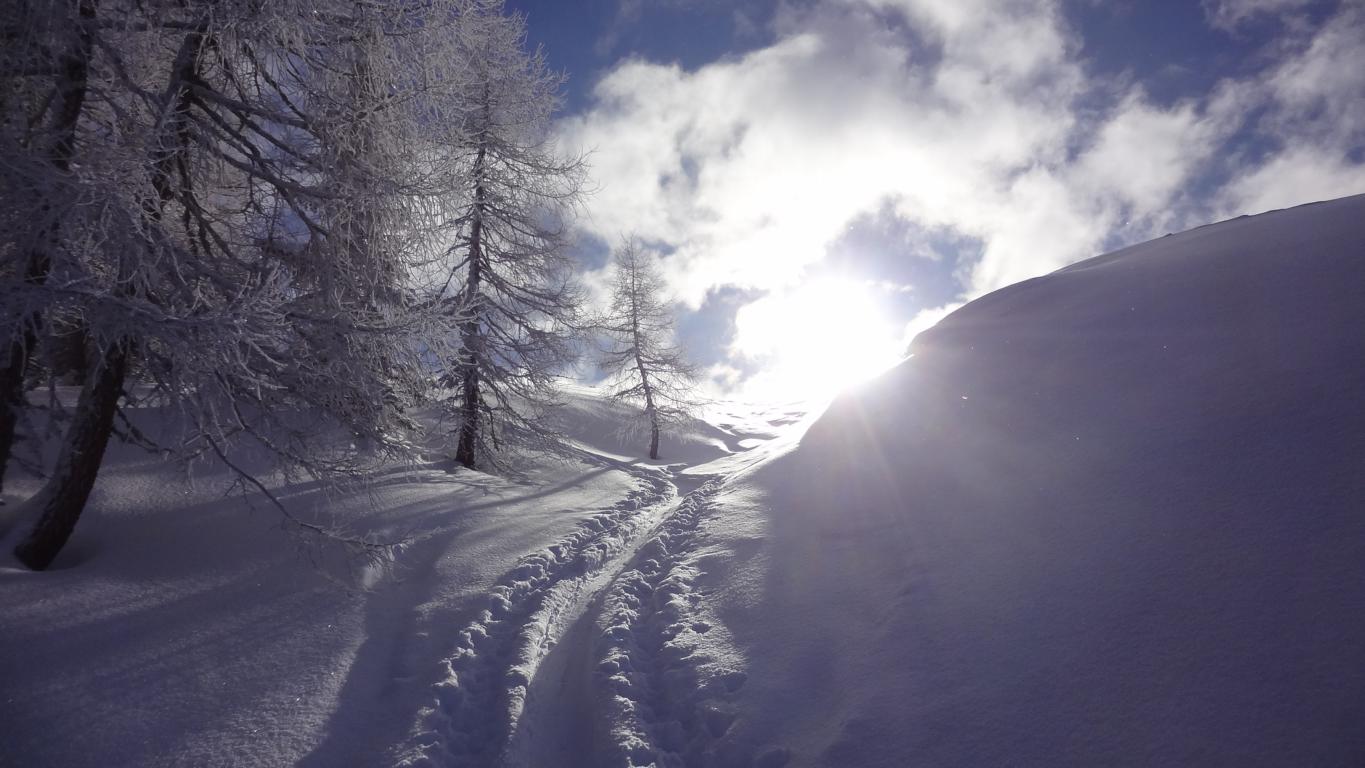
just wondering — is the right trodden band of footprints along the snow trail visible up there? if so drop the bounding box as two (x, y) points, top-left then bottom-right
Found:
(595, 477), (745, 768)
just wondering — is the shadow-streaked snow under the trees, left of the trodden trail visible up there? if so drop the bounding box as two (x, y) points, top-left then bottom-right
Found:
(0, 395), (704, 767)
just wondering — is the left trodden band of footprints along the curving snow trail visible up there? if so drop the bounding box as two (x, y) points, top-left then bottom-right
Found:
(399, 467), (677, 768)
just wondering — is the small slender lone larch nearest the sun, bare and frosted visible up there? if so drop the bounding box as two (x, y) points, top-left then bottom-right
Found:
(599, 237), (702, 458)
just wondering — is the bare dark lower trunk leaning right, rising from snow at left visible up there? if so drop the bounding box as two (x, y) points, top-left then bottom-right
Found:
(14, 341), (128, 570)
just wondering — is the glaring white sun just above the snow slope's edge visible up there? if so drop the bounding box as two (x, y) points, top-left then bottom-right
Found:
(734, 277), (905, 398)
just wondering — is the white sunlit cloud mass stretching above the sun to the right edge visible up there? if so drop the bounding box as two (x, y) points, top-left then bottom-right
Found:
(560, 0), (1365, 395)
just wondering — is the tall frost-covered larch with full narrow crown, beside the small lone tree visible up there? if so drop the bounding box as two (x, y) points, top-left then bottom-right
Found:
(445, 0), (583, 468)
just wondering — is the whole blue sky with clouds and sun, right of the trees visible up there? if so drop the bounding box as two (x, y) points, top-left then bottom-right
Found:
(508, 0), (1365, 396)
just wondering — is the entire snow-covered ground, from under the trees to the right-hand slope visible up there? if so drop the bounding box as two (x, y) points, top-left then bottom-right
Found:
(0, 196), (1365, 768)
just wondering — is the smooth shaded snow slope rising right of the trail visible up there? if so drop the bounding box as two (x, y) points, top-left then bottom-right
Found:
(711, 195), (1365, 767)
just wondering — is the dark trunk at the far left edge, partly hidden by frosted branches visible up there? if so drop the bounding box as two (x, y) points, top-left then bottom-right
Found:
(0, 0), (94, 492)
